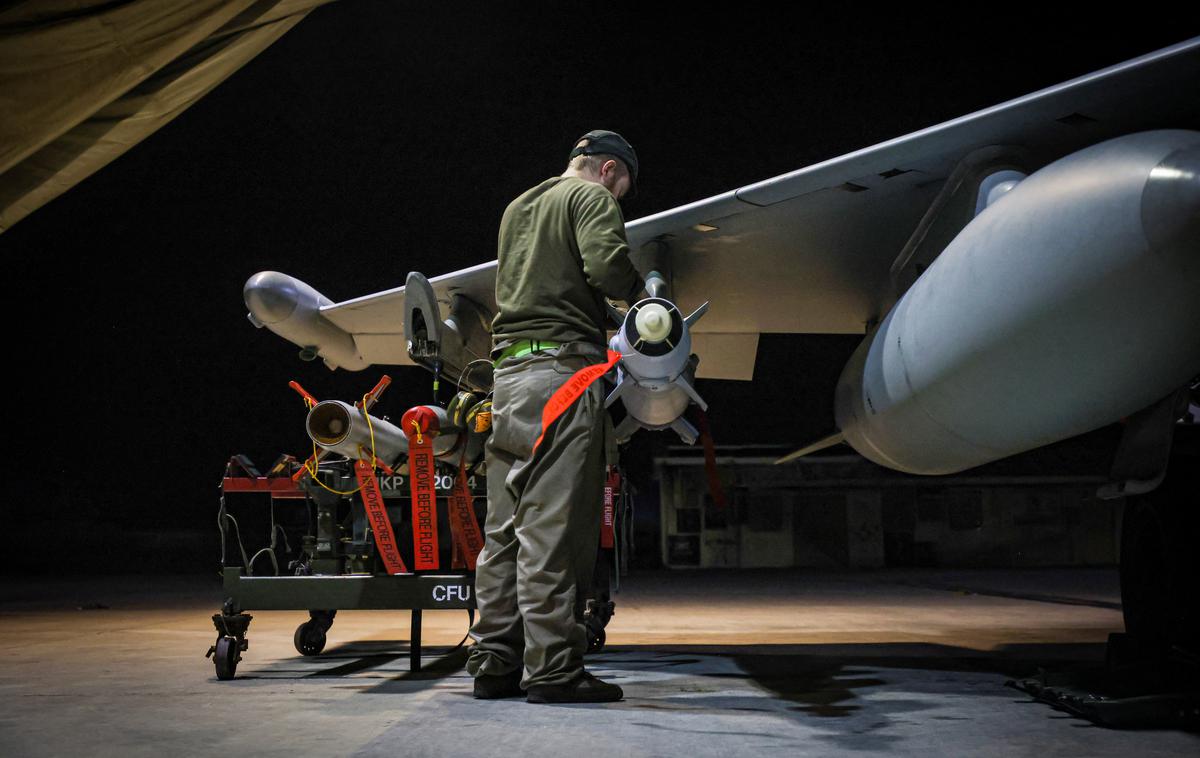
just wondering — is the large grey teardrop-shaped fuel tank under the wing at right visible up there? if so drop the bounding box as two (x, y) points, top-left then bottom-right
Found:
(835, 130), (1200, 474)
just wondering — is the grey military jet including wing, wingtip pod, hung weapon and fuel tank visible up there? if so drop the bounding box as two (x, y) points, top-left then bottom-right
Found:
(245, 38), (1200, 642)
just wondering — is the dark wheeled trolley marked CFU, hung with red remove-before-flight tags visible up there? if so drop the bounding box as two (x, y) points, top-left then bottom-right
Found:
(208, 377), (487, 679)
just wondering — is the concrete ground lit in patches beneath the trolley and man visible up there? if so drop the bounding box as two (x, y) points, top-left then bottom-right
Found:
(0, 570), (1200, 758)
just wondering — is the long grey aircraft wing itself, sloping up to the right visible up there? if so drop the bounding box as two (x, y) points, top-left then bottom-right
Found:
(300, 37), (1200, 379)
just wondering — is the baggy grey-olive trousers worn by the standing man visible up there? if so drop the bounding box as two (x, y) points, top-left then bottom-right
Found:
(467, 345), (608, 687)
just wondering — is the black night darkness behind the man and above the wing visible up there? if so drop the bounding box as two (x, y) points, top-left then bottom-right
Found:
(0, 0), (1200, 571)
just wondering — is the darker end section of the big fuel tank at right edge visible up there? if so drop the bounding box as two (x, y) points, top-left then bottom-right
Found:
(1141, 143), (1200, 275)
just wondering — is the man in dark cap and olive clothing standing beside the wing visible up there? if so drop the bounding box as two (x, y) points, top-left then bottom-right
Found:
(467, 131), (644, 703)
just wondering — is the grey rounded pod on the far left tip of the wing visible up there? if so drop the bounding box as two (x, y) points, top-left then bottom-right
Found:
(242, 271), (370, 371)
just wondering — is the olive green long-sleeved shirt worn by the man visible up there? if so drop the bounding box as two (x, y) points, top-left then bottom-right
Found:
(492, 176), (646, 347)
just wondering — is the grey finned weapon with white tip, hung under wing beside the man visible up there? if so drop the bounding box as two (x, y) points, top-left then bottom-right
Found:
(605, 272), (708, 445)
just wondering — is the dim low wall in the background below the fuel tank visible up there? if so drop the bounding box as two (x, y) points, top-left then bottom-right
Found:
(655, 455), (1122, 569)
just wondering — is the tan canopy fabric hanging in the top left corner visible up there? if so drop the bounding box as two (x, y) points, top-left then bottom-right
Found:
(0, 0), (330, 233)
